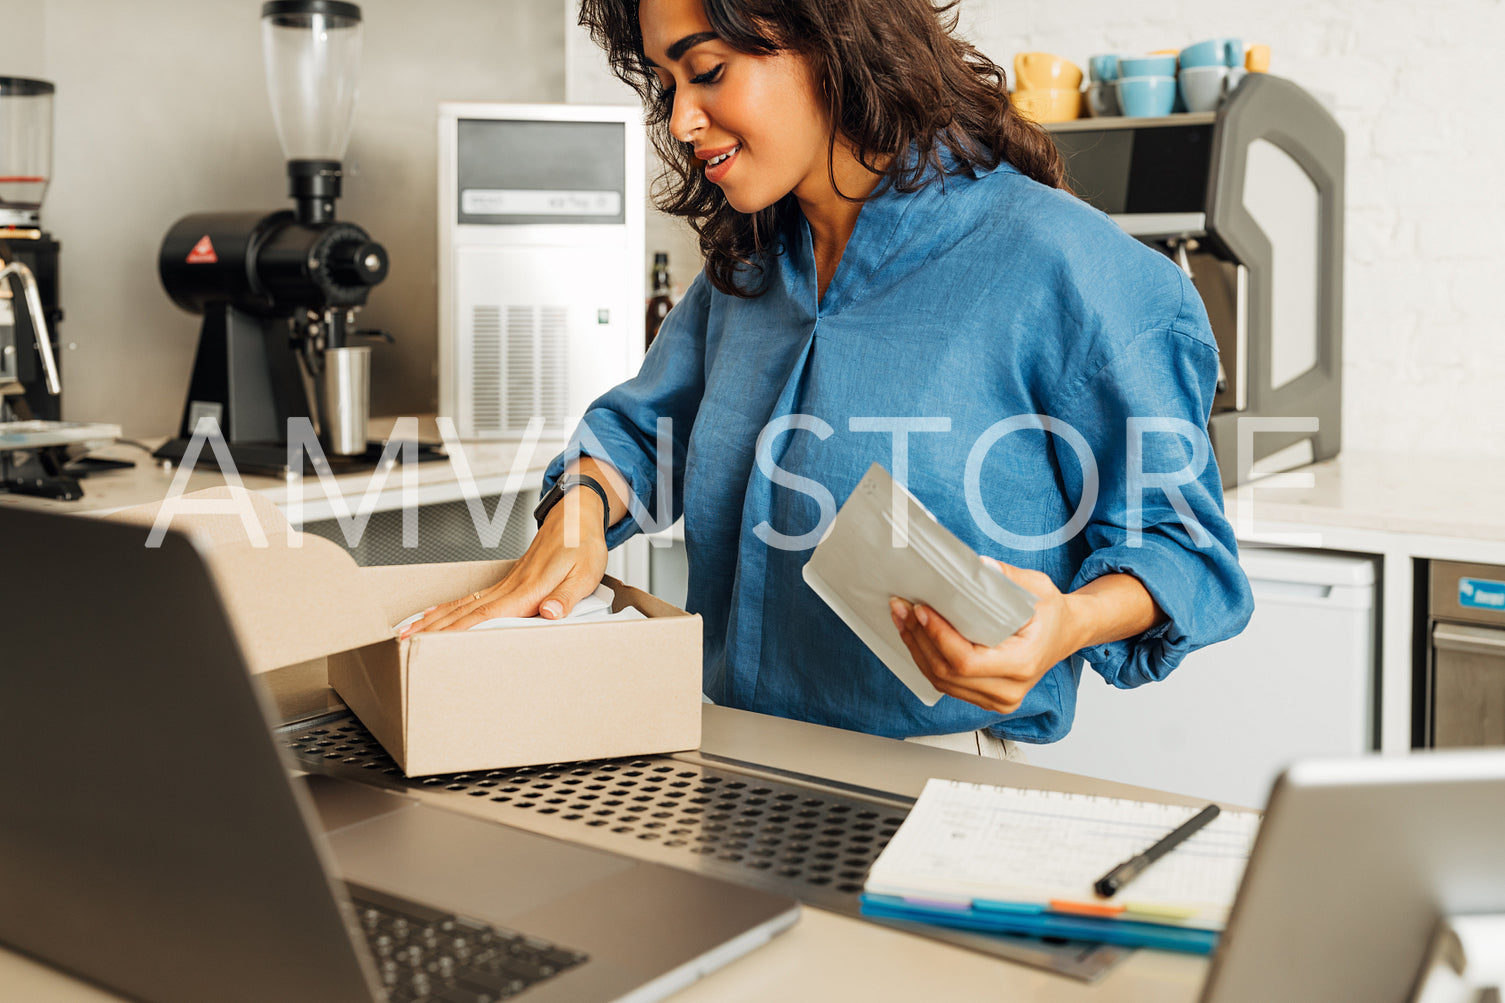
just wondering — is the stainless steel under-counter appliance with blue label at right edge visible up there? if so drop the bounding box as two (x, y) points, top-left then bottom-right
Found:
(1419, 560), (1505, 748)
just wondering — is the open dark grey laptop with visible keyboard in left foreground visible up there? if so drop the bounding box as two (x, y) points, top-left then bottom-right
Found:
(0, 509), (799, 1003)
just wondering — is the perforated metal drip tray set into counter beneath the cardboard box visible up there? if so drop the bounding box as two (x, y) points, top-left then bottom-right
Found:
(278, 712), (1130, 980)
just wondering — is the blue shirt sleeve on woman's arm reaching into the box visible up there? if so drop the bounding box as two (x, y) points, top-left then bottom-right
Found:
(543, 274), (710, 547)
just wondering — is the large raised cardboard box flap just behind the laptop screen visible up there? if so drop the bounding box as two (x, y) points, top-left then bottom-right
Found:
(107, 486), (391, 672)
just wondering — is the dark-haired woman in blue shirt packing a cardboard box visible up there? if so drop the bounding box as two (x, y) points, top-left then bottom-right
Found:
(406, 0), (1251, 755)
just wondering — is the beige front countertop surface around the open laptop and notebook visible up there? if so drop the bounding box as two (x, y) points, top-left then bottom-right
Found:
(0, 706), (1207, 1003)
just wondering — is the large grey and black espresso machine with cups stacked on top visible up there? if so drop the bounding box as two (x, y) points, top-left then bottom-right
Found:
(1044, 74), (1344, 488)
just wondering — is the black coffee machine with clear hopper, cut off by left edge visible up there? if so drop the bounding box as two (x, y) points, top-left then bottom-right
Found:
(0, 77), (120, 502)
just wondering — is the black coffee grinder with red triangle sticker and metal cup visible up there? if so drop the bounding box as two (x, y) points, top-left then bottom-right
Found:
(157, 0), (412, 474)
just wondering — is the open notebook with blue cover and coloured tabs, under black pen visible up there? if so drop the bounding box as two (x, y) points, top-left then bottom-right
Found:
(862, 780), (1260, 953)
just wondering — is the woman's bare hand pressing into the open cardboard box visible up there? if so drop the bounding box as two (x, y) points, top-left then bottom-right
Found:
(402, 488), (607, 637)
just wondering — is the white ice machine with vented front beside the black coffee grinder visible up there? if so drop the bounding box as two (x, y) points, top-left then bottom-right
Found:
(439, 104), (646, 440)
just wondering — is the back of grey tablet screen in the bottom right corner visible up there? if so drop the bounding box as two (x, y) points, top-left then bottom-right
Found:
(1201, 748), (1505, 1003)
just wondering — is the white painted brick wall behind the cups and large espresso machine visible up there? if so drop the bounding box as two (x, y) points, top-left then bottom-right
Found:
(960, 0), (1505, 459)
